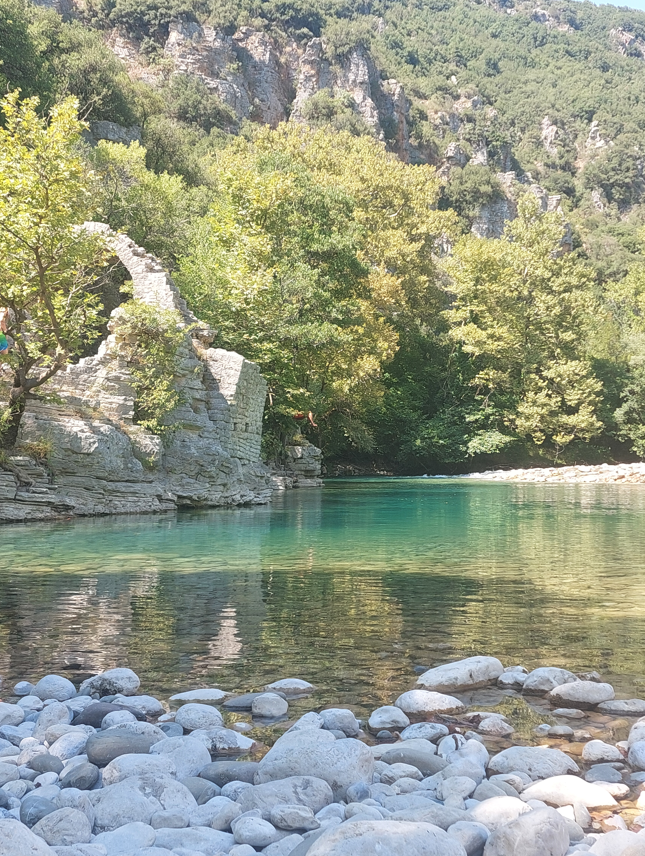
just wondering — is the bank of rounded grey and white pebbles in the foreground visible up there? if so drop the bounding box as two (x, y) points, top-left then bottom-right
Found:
(0, 657), (645, 856)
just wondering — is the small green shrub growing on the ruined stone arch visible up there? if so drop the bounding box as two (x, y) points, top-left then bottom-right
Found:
(118, 300), (186, 439)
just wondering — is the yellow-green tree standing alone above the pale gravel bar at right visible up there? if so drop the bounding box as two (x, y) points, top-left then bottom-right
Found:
(446, 195), (602, 459)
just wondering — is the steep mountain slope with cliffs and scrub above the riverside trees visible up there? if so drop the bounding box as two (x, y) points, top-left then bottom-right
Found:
(22, 0), (645, 276)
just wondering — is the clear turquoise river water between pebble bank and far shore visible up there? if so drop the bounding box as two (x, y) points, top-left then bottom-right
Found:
(0, 479), (645, 711)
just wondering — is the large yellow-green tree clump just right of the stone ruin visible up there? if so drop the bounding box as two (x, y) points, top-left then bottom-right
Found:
(177, 126), (453, 454)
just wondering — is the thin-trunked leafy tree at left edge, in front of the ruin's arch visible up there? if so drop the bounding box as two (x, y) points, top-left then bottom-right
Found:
(0, 92), (105, 445)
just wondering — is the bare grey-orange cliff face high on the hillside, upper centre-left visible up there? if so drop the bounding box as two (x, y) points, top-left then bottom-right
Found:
(107, 20), (415, 161)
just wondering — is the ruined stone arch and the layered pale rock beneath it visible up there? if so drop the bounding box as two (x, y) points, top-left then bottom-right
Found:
(0, 224), (273, 522)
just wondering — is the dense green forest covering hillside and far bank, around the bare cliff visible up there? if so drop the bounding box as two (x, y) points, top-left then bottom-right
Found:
(0, 0), (645, 472)
